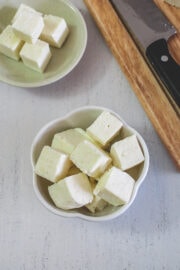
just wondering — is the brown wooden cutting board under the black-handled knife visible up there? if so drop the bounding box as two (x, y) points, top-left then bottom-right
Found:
(84, 0), (180, 169)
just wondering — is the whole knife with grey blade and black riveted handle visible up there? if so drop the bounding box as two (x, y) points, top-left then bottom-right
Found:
(111, 0), (180, 106)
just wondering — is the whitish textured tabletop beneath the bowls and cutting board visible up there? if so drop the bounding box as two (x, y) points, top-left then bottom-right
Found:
(0, 0), (180, 270)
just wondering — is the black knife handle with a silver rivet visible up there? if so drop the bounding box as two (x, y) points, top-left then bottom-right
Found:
(146, 39), (180, 106)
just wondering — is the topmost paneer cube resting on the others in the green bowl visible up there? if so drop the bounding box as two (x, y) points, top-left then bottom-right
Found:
(12, 10), (44, 44)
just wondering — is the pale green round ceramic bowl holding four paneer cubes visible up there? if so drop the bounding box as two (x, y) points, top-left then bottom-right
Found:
(0, 0), (87, 87)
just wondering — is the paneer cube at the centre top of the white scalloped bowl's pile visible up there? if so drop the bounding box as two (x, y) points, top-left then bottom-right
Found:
(70, 140), (112, 178)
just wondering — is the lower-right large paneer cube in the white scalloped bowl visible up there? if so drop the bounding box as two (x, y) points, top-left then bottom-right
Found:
(94, 167), (135, 206)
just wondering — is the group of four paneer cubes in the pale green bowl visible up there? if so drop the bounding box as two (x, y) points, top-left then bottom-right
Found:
(0, 4), (69, 73)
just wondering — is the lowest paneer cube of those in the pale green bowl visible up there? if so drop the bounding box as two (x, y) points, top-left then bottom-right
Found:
(20, 40), (52, 73)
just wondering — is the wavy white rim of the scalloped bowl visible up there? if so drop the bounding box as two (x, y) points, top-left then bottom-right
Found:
(30, 105), (150, 221)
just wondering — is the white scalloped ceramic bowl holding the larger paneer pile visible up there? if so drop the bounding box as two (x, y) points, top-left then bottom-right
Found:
(31, 106), (149, 221)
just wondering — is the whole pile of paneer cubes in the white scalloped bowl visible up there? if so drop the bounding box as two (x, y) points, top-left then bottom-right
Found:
(35, 111), (144, 213)
